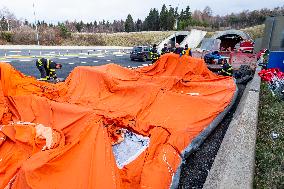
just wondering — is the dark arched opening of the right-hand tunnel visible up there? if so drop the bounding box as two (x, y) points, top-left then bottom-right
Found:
(217, 34), (244, 51)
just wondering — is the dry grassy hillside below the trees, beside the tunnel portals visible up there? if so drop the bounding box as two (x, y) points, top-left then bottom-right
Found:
(0, 24), (265, 46)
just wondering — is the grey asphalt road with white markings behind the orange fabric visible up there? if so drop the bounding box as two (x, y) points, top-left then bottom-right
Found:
(0, 49), (151, 78)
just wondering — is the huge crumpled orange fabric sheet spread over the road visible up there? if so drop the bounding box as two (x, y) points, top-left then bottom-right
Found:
(0, 54), (236, 189)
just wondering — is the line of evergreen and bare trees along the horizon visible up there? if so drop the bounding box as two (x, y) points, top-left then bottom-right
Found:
(0, 5), (284, 37)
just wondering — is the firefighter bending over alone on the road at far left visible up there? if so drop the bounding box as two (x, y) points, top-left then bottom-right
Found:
(36, 58), (62, 81)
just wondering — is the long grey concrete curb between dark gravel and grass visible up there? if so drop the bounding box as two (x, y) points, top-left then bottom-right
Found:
(203, 69), (261, 189)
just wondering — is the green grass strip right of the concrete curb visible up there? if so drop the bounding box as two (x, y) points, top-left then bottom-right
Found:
(254, 83), (284, 189)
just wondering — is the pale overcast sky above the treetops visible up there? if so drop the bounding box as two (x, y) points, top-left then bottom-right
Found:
(0, 0), (284, 23)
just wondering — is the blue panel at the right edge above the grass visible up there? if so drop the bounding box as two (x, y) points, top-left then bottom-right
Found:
(267, 51), (284, 72)
